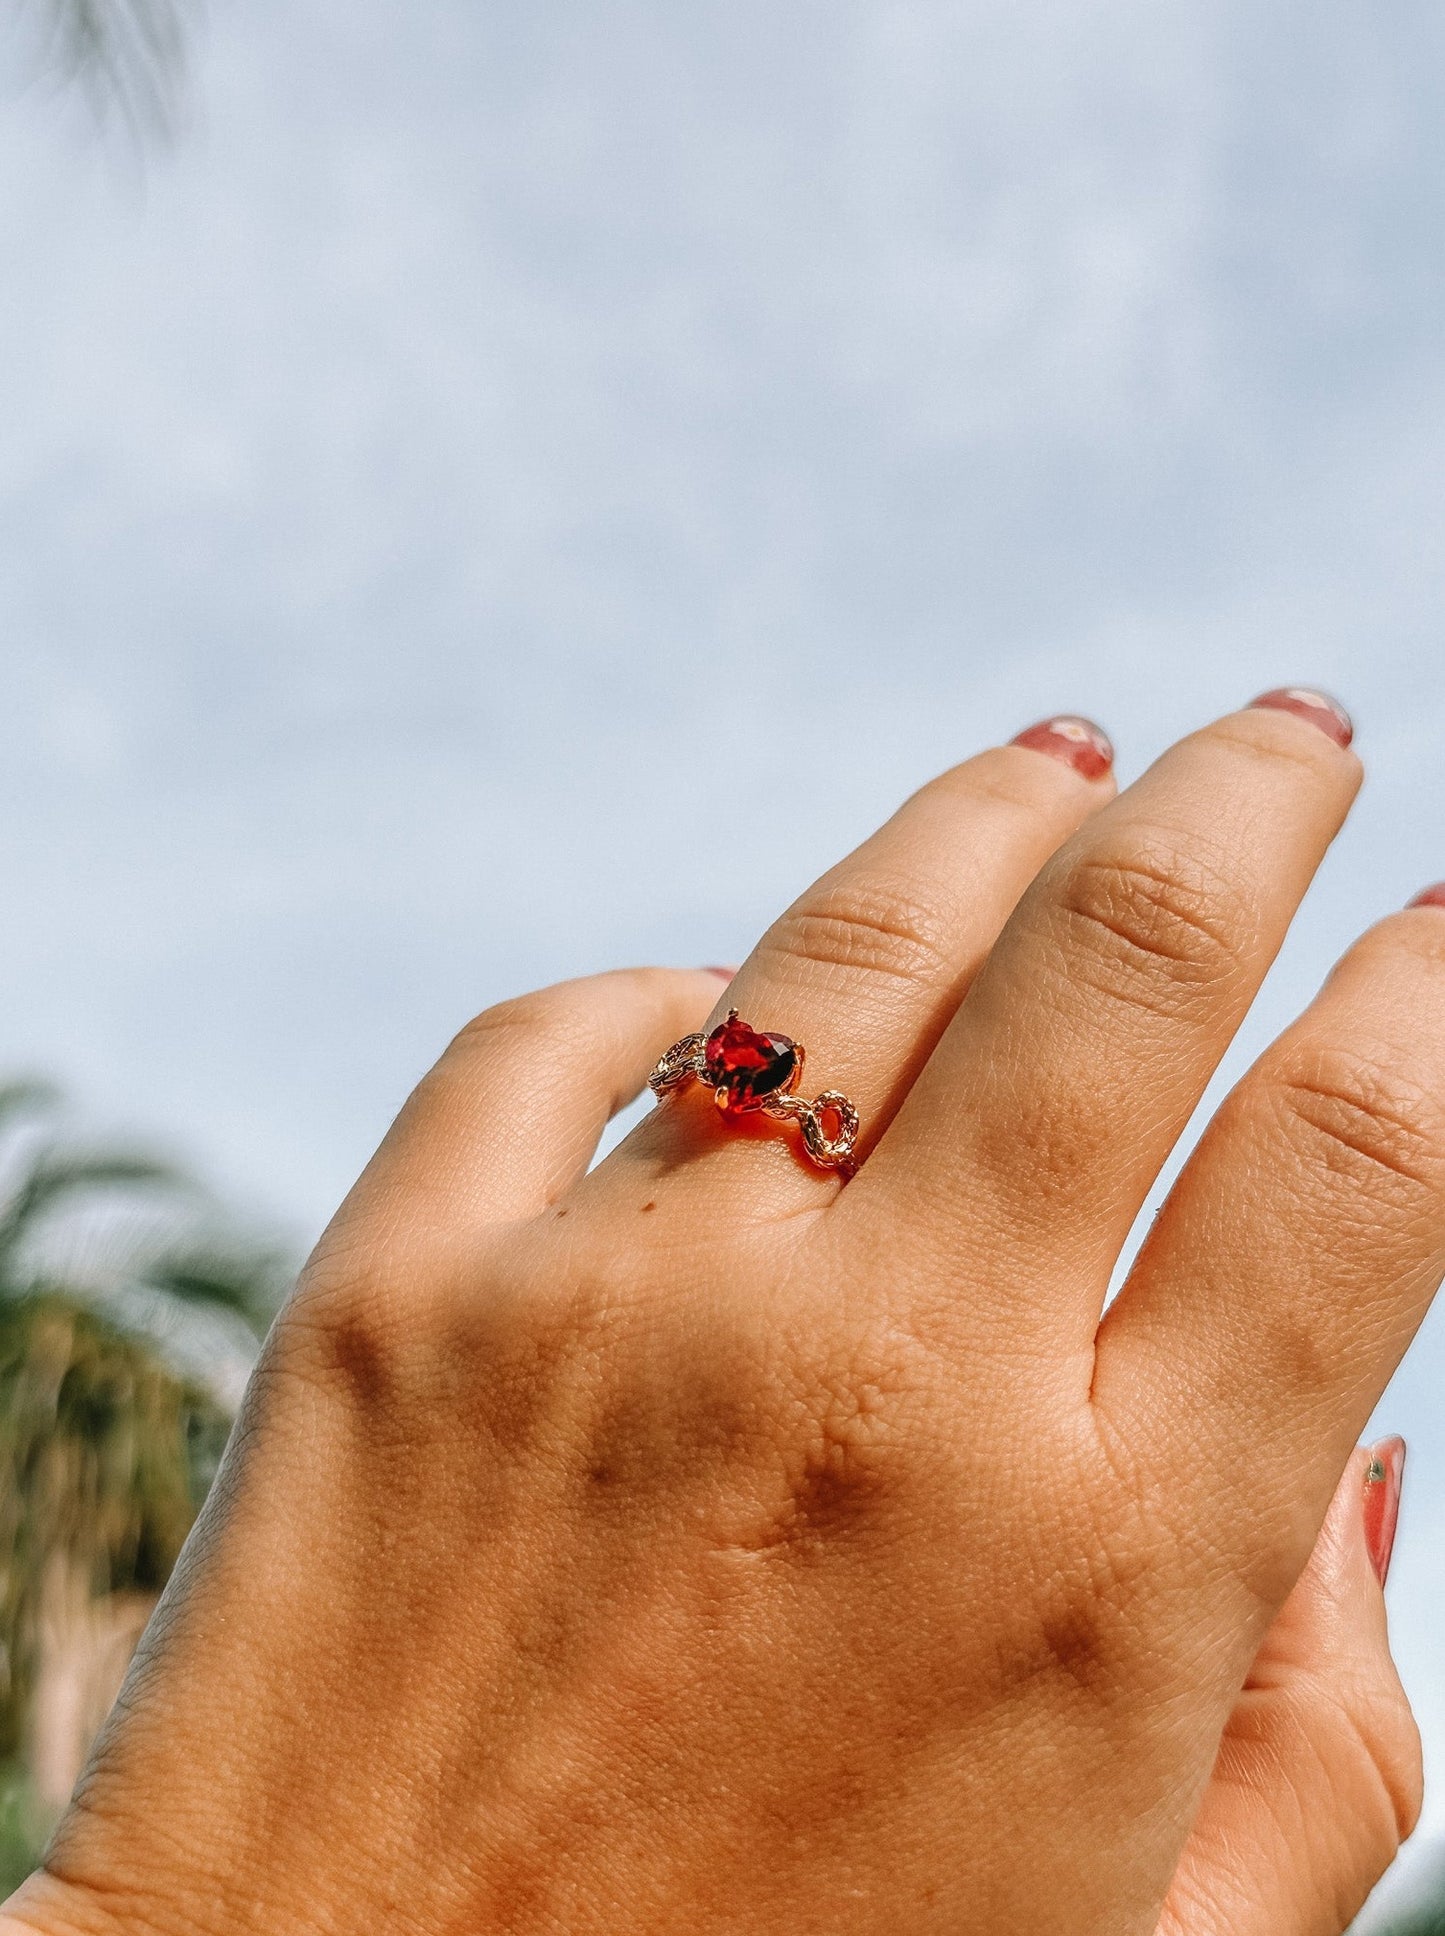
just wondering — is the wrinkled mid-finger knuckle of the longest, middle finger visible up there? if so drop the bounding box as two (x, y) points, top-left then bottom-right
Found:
(1058, 846), (1257, 1014)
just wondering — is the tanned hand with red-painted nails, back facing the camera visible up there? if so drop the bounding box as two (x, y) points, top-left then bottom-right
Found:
(10, 695), (1445, 1936)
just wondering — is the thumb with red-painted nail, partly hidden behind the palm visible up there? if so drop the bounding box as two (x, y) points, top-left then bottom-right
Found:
(1158, 1440), (1422, 1936)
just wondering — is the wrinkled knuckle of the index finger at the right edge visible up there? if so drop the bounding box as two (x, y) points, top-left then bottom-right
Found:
(1269, 1045), (1445, 1210)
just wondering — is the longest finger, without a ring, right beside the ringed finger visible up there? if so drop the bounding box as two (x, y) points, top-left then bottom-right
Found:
(867, 689), (1360, 1351)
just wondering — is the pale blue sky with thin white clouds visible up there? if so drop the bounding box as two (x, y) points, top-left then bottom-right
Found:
(0, 0), (1445, 1889)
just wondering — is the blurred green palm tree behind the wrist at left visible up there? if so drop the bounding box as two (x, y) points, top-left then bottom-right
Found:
(0, 1082), (287, 1888)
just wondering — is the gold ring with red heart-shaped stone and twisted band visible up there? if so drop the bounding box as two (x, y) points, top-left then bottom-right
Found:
(647, 1009), (858, 1177)
